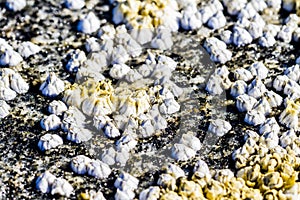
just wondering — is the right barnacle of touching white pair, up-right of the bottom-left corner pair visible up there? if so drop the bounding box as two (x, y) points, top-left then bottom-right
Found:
(87, 160), (111, 179)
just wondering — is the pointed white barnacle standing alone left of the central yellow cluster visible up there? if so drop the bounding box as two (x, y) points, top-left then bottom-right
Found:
(40, 73), (65, 97)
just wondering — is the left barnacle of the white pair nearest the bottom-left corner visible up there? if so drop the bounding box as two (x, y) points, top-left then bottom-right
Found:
(35, 171), (56, 193)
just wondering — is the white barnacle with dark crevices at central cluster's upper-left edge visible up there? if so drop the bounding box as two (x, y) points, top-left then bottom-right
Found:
(66, 49), (87, 72)
